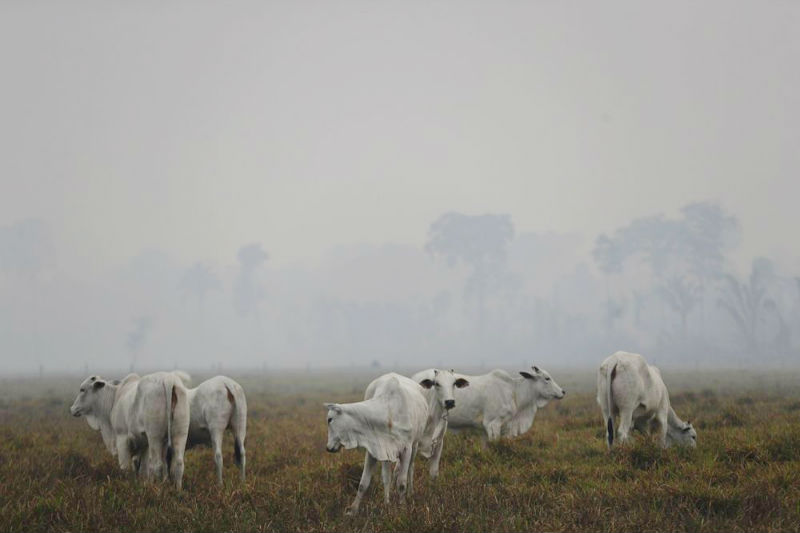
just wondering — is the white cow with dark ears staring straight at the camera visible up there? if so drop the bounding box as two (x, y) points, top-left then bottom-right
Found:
(412, 369), (469, 478)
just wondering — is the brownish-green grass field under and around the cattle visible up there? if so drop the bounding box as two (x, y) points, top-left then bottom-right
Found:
(0, 370), (800, 531)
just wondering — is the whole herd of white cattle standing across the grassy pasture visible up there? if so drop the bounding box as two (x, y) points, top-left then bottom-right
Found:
(70, 352), (697, 514)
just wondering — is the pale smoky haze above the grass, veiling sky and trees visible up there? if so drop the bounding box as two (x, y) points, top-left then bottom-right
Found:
(0, 1), (800, 373)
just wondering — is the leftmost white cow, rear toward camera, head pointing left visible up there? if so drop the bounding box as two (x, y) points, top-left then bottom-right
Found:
(70, 372), (189, 489)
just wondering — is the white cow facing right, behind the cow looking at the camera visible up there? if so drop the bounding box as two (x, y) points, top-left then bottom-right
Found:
(414, 366), (566, 440)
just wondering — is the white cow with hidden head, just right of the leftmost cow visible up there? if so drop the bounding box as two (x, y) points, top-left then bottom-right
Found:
(186, 376), (247, 484)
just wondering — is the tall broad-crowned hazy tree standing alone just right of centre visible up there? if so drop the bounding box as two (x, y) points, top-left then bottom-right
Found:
(425, 212), (514, 332)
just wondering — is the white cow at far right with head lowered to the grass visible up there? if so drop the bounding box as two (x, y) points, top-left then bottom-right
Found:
(597, 352), (697, 449)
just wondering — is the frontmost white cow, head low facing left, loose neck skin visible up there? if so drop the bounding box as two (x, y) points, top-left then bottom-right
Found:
(325, 373), (428, 514)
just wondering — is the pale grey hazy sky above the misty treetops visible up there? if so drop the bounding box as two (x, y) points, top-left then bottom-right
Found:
(0, 0), (800, 273)
